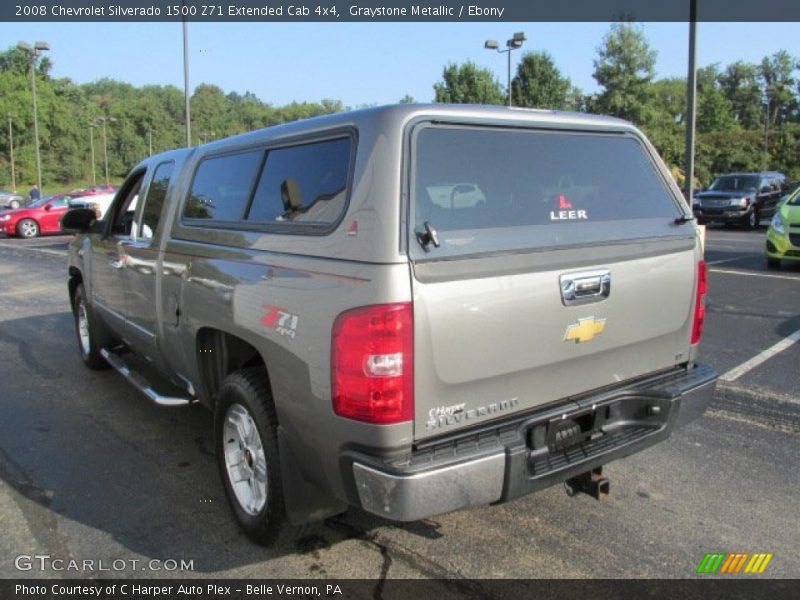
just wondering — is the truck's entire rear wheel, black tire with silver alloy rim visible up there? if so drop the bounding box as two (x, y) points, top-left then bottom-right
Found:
(214, 368), (300, 546)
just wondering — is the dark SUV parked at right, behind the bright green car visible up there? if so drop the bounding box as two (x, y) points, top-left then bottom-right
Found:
(694, 171), (788, 229)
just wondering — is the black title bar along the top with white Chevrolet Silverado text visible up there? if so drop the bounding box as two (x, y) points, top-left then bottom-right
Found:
(0, 0), (800, 23)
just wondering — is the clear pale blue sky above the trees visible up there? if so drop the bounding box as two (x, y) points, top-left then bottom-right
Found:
(0, 23), (800, 107)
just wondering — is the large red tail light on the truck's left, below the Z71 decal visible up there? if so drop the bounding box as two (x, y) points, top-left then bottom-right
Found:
(331, 303), (414, 424)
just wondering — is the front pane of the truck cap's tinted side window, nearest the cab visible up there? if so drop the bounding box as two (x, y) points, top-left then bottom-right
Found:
(183, 150), (264, 221)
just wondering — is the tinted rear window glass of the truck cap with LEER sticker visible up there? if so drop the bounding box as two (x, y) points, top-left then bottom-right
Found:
(412, 126), (681, 256)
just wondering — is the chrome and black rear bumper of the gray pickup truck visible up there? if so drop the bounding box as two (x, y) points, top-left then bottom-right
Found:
(347, 365), (717, 521)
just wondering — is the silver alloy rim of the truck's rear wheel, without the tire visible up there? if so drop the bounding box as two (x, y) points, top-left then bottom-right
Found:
(222, 404), (267, 516)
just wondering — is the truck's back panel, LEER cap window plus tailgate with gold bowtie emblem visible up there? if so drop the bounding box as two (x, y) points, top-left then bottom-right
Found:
(410, 126), (699, 439)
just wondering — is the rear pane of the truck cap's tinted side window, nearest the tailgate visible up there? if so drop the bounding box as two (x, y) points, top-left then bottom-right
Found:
(247, 138), (351, 225)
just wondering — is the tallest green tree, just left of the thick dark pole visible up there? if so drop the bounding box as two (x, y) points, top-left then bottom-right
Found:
(594, 23), (656, 124)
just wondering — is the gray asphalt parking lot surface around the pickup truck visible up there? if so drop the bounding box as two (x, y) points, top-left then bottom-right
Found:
(0, 228), (800, 580)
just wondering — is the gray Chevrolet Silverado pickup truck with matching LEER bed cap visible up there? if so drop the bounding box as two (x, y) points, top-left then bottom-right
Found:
(63, 105), (716, 543)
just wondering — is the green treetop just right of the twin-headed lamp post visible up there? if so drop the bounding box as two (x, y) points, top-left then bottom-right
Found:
(511, 52), (572, 110)
